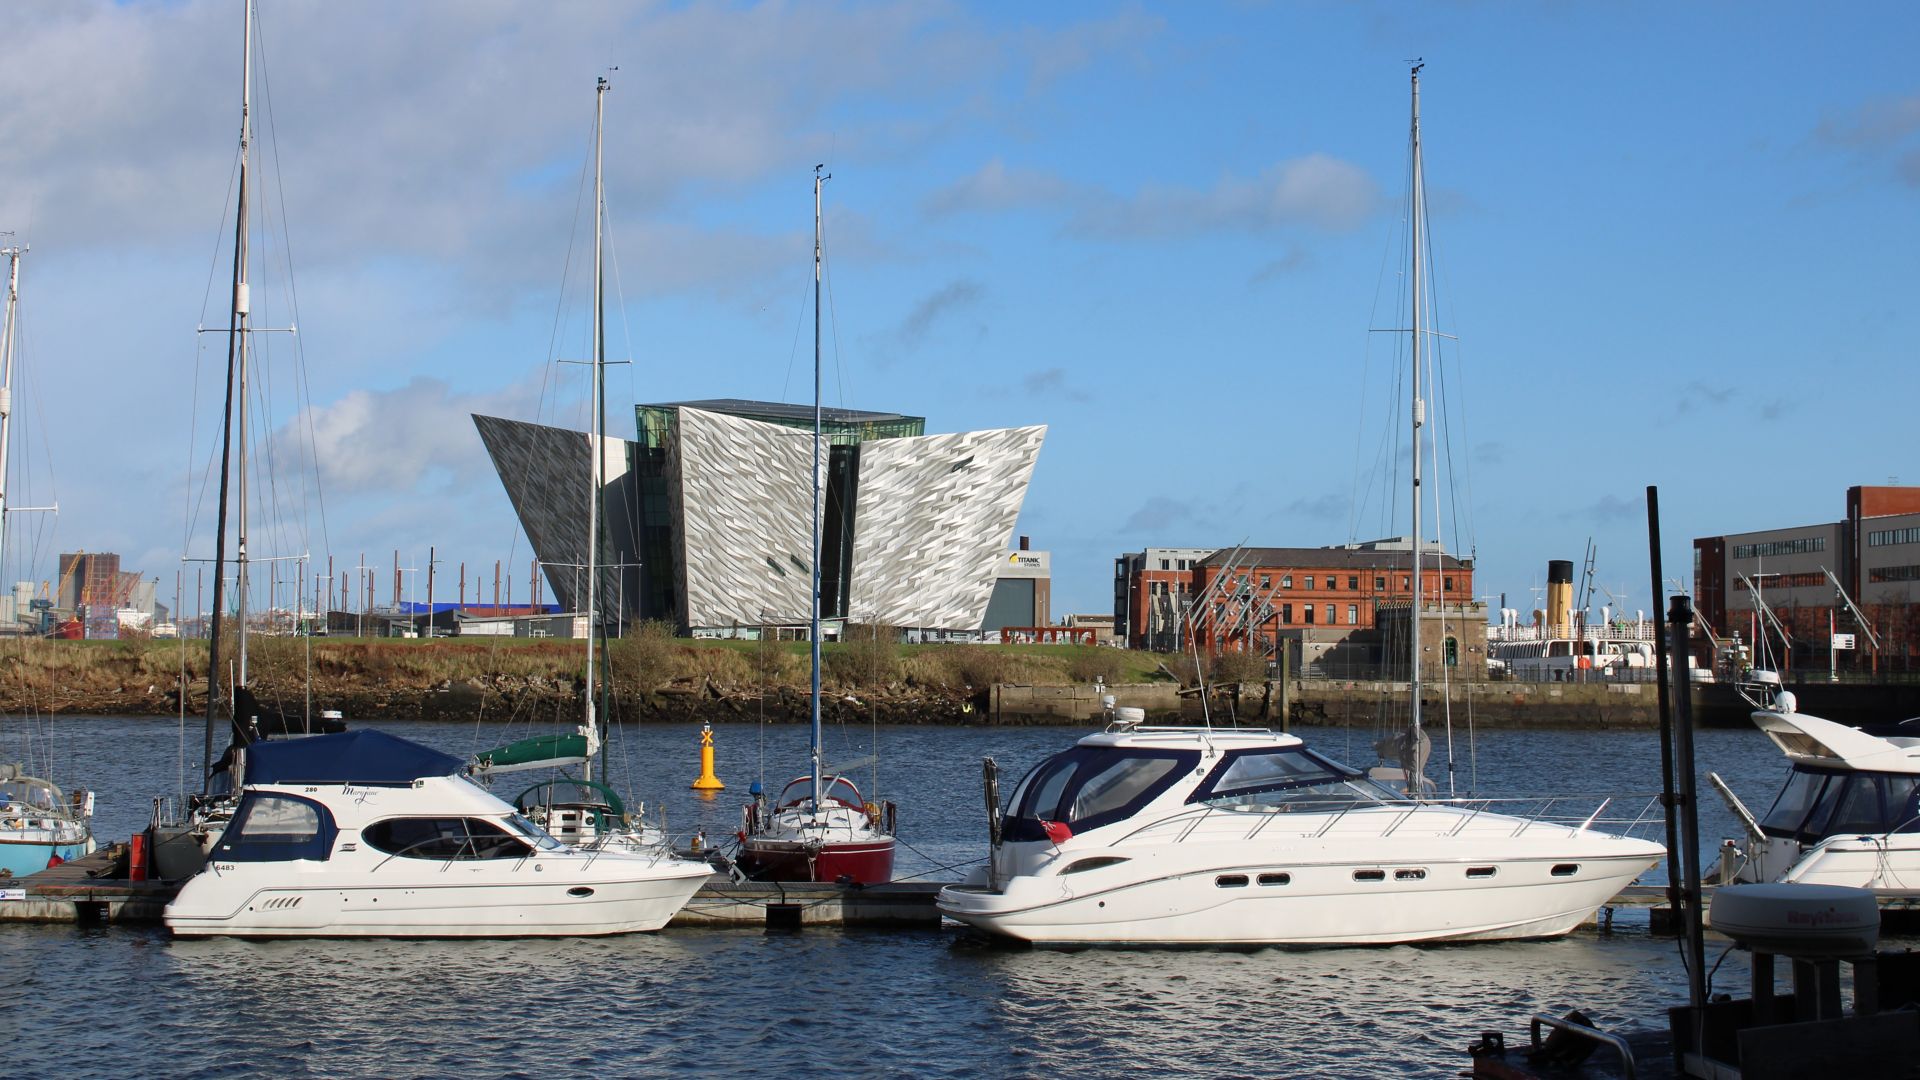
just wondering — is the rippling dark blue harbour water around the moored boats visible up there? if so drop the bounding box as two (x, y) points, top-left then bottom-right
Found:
(0, 719), (1827, 1076)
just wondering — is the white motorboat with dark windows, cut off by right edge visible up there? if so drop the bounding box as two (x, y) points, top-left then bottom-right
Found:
(1709, 692), (1920, 897)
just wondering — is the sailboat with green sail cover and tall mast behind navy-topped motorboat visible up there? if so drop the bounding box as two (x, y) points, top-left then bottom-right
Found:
(474, 77), (666, 849)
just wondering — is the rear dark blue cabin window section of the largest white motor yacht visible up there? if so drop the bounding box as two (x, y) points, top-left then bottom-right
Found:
(1000, 746), (1200, 842)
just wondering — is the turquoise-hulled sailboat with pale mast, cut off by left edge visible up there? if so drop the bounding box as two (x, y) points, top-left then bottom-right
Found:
(0, 244), (94, 878)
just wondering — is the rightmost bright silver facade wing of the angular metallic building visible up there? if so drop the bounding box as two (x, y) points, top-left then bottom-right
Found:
(847, 425), (1046, 630)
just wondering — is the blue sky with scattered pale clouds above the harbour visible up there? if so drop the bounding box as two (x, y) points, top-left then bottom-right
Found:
(0, 0), (1920, 617)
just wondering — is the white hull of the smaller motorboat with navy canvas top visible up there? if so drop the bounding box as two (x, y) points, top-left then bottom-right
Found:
(165, 857), (710, 938)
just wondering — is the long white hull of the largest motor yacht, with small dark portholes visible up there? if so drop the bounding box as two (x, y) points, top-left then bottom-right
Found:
(939, 853), (1657, 945)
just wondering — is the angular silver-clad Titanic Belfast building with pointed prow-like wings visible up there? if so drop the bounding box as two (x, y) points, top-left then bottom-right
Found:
(474, 400), (1046, 634)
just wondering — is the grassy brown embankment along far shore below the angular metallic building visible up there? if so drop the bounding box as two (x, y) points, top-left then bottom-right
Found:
(0, 626), (1165, 721)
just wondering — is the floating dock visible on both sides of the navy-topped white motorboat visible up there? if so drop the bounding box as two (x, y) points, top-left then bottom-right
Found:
(0, 844), (943, 930)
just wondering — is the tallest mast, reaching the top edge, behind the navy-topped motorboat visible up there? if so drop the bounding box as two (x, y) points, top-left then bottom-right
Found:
(202, 0), (253, 790)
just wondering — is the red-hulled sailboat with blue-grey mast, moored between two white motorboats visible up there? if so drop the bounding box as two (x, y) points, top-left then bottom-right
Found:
(737, 165), (895, 884)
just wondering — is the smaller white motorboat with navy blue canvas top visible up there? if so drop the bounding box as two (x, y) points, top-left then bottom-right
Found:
(165, 730), (712, 938)
